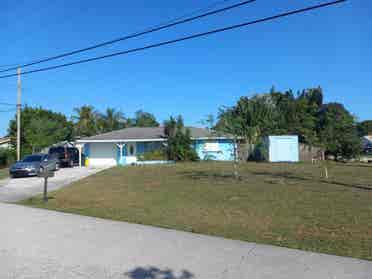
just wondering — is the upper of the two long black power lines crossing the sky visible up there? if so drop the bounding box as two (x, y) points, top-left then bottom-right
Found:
(0, 0), (256, 73)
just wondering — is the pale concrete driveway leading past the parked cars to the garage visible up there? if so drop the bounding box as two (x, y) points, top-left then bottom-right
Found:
(0, 167), (105, 202)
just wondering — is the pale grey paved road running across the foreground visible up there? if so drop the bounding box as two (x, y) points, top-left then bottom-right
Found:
(0, 203), (372, 279)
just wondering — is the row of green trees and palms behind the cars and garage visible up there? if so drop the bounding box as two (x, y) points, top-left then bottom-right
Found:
(8, 106), (159, 158)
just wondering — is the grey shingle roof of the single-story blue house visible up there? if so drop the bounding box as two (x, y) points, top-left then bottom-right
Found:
(79, 127), (230, 142)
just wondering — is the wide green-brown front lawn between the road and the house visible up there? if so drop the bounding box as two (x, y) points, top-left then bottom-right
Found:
(22, 162), (372, 260)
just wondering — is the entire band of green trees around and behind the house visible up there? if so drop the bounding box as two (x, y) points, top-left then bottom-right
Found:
(3, 87), (372, 160)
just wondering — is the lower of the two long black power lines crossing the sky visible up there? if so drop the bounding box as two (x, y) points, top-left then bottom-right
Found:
(0, 0), (346, 79)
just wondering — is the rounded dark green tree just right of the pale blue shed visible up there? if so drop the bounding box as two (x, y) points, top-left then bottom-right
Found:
(318, 103), (361, 160)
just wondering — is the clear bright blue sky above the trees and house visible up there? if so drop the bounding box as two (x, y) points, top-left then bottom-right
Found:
(0, 0), (372, 135)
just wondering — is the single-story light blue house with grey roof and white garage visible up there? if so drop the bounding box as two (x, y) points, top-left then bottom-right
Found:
(76, 127), (235, 166)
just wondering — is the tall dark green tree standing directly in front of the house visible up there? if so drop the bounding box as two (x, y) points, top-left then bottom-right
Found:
(164, 116), (198, 161)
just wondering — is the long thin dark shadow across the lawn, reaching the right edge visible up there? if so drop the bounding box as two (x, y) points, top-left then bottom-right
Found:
(251, 171), (372, 191)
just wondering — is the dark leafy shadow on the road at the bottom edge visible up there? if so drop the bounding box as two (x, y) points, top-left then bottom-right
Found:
(125, 267), (195, 279)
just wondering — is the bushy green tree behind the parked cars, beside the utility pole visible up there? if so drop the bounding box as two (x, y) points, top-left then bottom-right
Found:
(8, 107), (73, 155)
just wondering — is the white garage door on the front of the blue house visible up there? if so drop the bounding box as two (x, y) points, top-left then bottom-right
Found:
(89, 143), (117, 166)
